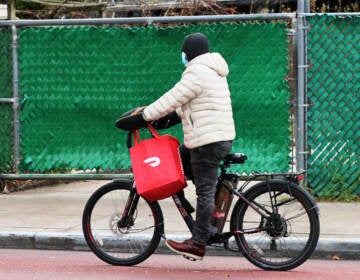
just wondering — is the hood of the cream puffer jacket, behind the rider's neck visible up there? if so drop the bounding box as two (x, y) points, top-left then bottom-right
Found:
(187, 53), (229, 77)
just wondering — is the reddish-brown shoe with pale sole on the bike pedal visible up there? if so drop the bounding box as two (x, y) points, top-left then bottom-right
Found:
(166, 239), (205, 260)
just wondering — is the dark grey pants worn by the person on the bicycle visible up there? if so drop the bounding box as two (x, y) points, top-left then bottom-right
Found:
(180, 141), (232, 245)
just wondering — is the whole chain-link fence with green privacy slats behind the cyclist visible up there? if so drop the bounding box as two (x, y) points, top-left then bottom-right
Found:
(0, 14), (360, 196)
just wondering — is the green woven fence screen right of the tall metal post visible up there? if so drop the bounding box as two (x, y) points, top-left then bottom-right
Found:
(307, 16), (360, 197)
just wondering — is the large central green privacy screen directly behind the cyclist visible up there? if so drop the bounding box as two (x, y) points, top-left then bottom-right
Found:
(19, 23), (290, 172)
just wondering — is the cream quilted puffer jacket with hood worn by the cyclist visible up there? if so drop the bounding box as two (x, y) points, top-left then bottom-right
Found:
(144, 53), (235, 149)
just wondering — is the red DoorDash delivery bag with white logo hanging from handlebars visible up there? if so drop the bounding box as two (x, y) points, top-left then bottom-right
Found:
(130, 125), (186, 201)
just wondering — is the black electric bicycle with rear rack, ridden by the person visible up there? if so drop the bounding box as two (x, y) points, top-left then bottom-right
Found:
(82, 112), (320, 270)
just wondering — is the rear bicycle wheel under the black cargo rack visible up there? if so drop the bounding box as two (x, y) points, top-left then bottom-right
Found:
(230, 180), (320, 271)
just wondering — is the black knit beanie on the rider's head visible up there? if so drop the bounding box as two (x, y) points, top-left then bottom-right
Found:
(182, 33), (209, 61)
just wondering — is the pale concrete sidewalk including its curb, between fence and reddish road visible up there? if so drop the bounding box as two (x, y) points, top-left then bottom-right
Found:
(0, 180), (360, 260)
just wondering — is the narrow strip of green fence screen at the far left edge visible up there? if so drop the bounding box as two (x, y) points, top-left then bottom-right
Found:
(0, 28), (14, 173)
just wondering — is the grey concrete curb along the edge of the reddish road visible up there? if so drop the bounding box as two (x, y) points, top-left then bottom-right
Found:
(0, 232), (360, 260)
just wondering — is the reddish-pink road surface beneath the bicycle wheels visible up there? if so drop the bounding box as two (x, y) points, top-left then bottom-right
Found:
(0, 249), (360, 280)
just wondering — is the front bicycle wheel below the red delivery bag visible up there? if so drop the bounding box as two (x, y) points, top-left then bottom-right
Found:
(82, 180), (163, 266)
